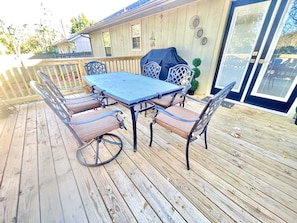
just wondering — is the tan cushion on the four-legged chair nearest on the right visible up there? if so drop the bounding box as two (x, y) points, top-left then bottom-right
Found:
(156, 106), (199, 139)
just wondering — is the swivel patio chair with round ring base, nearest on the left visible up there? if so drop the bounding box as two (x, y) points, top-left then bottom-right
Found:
(30, 81), (125, 167)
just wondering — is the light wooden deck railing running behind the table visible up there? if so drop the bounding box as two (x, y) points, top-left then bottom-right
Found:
(0, 56), (141, 104)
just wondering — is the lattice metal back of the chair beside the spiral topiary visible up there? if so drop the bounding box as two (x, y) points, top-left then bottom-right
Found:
(165, 64), (194, 94)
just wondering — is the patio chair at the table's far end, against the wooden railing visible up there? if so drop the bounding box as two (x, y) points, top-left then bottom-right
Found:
(84, 61), (117, 106)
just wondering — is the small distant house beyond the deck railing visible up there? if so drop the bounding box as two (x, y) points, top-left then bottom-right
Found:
(54, 34), (92, 54)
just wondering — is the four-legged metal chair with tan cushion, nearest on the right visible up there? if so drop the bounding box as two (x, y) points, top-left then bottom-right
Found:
(149, 82), (235, 170)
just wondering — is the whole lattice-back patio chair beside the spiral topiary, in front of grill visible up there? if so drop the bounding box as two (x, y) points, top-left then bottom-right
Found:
(152, 64), (193, 108)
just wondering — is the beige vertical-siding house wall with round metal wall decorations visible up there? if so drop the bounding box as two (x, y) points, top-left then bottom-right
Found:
(90, 0), (231, 94)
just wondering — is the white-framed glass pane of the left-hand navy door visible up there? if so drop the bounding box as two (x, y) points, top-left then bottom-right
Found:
(215, 1), (270, 93)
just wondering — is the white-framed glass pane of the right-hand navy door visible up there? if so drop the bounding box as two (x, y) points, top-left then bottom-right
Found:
(251, 1), (297, 101)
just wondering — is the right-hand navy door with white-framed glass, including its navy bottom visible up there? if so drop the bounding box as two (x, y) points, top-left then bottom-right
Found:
(245, 0), (297, 112)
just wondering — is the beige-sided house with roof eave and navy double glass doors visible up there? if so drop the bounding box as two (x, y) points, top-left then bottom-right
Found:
(78, 0), (297, 116)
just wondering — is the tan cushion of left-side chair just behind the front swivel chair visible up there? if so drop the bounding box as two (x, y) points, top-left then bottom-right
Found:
(65, 96), (100, 114)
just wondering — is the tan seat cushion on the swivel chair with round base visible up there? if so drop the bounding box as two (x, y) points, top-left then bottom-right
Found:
(70, 108), (120, 141)
